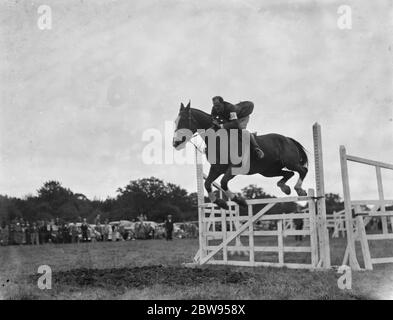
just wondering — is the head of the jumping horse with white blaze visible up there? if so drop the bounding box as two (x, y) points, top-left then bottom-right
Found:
(173, 102), (198, 150)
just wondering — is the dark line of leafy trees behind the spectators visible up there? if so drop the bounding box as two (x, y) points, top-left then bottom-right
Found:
(0, 177), (344, 223)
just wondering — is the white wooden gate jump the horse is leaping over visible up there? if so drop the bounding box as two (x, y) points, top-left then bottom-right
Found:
(187, 123), (331, 269)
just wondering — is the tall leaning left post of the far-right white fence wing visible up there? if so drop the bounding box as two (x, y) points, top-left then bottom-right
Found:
(340, 146), (360, 270)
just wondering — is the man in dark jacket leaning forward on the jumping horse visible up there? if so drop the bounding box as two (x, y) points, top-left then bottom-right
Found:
(211, 96), (264, 159)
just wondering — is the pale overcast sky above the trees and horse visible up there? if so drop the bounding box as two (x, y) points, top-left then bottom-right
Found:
(0, 0), (393, 199)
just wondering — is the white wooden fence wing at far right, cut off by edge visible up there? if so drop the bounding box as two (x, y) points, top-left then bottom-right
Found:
(340, 146), (393, 270)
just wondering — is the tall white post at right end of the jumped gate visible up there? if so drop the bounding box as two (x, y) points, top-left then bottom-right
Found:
(313, 123), (331, 268)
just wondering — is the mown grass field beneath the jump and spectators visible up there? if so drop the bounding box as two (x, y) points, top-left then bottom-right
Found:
(0, 239), (393, 299)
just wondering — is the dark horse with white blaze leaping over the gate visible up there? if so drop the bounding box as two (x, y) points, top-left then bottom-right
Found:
(173, 103), (308, 209)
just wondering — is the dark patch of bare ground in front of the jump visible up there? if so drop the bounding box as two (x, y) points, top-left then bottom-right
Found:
(32, 266), (252, 289)
